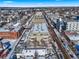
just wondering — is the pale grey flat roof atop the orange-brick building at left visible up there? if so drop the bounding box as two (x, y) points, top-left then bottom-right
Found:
(0, 23), (21, 32)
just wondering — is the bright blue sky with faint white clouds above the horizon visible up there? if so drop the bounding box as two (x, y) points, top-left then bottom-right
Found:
(0, 0), (79, 7)
